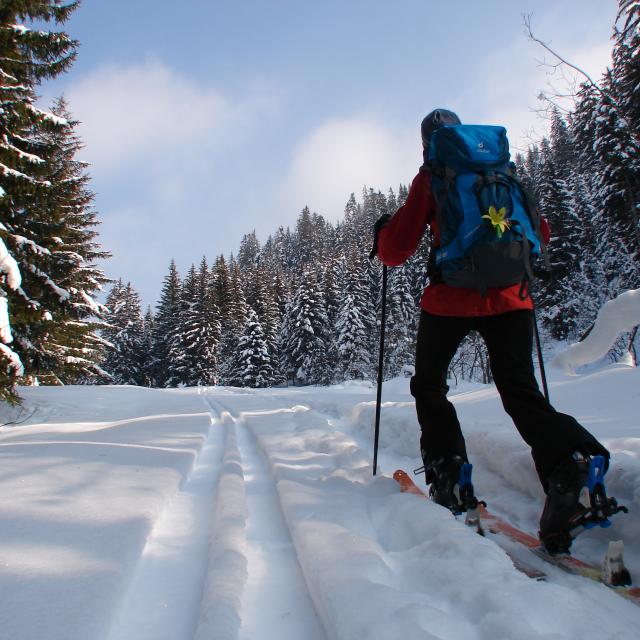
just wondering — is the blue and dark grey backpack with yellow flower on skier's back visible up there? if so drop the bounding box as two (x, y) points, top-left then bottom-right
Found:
(427, 124), (544, 297)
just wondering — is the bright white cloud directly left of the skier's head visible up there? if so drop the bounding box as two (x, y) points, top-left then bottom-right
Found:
(278, 116), (421, 220)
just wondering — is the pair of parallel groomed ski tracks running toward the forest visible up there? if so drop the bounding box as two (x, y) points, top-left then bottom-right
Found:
(108, 391), (326, 640)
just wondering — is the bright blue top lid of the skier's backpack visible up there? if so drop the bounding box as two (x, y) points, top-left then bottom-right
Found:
(429, 124), (511, 173)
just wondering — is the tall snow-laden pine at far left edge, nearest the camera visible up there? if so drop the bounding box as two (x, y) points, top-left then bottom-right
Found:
(0, 0), (79, 400)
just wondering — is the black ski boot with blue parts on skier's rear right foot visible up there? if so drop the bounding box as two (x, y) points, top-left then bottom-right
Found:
(538, 451), (628, 555)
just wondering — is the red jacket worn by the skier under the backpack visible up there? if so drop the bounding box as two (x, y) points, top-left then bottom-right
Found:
(378, 171), (549, 317)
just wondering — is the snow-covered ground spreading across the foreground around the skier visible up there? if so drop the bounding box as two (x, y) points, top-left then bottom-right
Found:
(0, 364), (640, 640)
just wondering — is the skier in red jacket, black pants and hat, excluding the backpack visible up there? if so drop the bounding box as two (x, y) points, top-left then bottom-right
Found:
(374, 109), (609, 554)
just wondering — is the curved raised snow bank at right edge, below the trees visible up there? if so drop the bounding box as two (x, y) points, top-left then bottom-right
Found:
(552, 289), (640, 373)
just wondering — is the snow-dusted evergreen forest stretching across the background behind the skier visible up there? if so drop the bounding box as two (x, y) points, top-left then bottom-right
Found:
(0, 0), (640, 400)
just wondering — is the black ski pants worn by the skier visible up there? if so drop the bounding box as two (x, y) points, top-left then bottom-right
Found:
(411, 310), (609, 490)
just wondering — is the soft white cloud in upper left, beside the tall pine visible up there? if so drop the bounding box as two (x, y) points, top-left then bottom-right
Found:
(66, 60), (278, 173)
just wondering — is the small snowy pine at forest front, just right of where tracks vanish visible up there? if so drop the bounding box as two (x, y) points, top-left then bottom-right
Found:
(228, 308), (274, 388)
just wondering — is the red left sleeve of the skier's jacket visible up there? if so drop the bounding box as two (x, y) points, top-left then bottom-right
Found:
(378, 171), (435, 267)
